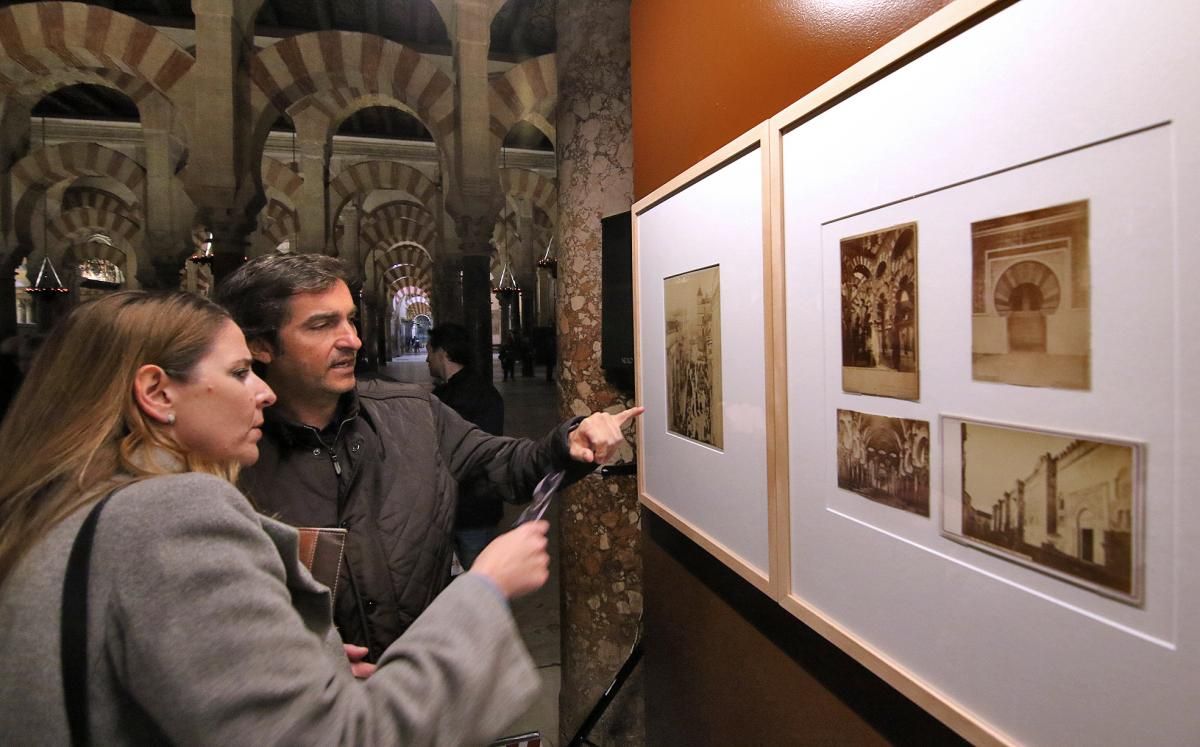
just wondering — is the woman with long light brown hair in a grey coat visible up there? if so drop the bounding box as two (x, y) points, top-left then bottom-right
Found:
(0, 292), (548, 745)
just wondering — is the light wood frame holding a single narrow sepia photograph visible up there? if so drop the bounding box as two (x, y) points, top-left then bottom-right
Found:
(632, 126), (781, 593)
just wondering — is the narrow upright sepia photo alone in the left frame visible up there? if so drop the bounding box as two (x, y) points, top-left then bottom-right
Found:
(664, 265), (725, 449)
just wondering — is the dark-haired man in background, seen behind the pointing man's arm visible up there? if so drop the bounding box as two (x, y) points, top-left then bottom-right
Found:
(425, 324), (504, 569)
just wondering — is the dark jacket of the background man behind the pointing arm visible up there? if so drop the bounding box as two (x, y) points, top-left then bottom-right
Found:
(433, 369), (504, 530)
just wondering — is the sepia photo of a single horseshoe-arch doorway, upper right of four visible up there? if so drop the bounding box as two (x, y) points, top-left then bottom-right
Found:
(971, 199), (1092, 389)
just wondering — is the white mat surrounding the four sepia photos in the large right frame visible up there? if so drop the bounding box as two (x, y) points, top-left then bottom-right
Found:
(781, 0), (1200, 745)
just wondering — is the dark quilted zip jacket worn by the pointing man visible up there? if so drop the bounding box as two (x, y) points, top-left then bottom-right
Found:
(241, 381), (590, 661)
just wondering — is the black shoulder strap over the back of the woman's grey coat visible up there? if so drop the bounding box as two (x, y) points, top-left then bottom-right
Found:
(59, 494), (113, 747)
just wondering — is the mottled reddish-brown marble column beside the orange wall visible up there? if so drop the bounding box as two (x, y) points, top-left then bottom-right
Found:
(556, 0), (646, 746)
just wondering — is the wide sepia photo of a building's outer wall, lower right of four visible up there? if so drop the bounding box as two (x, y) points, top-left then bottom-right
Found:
(943, 422), (1142, 603)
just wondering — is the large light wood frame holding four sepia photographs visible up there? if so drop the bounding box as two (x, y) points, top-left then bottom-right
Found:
(777, 0), (1200, 745)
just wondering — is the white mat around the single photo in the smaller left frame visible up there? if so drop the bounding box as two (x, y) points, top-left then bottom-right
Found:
(635, 147), (770, 578)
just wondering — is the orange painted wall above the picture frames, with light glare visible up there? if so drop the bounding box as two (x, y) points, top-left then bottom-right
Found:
(630, 0), (949, 199)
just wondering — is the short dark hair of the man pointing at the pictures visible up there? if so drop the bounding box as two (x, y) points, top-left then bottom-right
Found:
(212, 255), (350, 351)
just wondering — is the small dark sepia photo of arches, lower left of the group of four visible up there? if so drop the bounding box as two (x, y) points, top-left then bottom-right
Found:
(838, 410), (929, 516)
